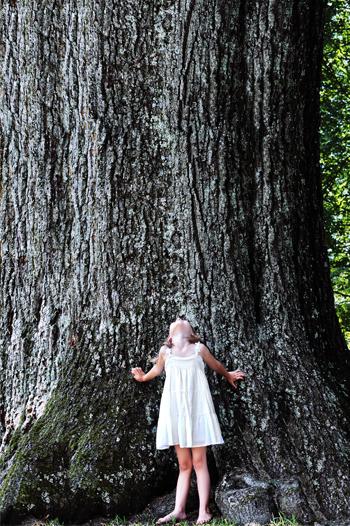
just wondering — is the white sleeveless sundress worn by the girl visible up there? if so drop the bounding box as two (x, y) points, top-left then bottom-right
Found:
(156, 342), (224, 449)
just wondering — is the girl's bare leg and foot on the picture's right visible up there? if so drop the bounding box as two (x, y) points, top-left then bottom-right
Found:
(192, 446), (212, 524)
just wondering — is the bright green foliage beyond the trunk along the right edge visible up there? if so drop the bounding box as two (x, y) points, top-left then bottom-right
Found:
(320, 0), (350, 344)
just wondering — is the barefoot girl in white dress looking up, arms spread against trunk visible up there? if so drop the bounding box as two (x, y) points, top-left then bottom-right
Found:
(131, 318), (245, 524)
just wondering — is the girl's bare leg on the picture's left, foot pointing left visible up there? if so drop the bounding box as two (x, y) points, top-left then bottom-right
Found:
(156, 444), (192, 524)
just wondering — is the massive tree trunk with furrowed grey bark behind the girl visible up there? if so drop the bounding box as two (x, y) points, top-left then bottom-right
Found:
(0, 0), (350, 522)
